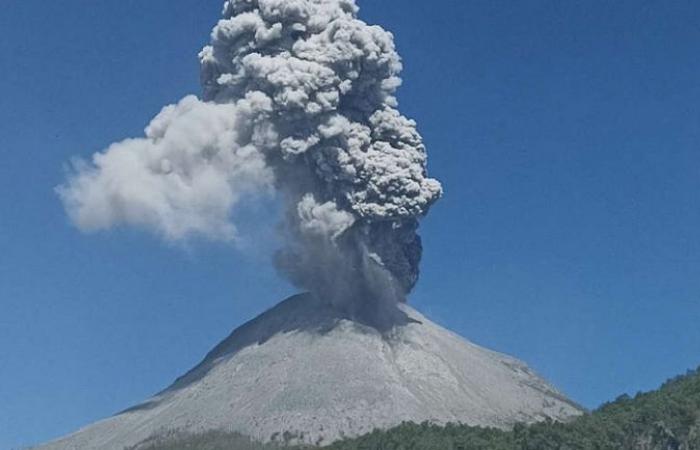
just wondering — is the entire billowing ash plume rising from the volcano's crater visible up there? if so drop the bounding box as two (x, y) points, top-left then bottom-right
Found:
(58, 0), (441, 318)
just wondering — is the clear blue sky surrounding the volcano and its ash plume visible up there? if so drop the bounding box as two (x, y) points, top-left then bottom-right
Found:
(0, 0), (700, 448)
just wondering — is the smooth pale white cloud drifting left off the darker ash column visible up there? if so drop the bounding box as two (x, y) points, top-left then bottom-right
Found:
(58, 96), (274, 240)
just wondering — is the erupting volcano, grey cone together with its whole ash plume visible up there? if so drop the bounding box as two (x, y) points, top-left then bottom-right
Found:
(41, 0), (579, 448)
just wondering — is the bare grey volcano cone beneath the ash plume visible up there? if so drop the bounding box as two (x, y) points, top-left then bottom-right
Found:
(39, 295), (581, 450)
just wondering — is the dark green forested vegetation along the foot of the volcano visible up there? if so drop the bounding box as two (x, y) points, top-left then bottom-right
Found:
(130, 369), (700, 450)
